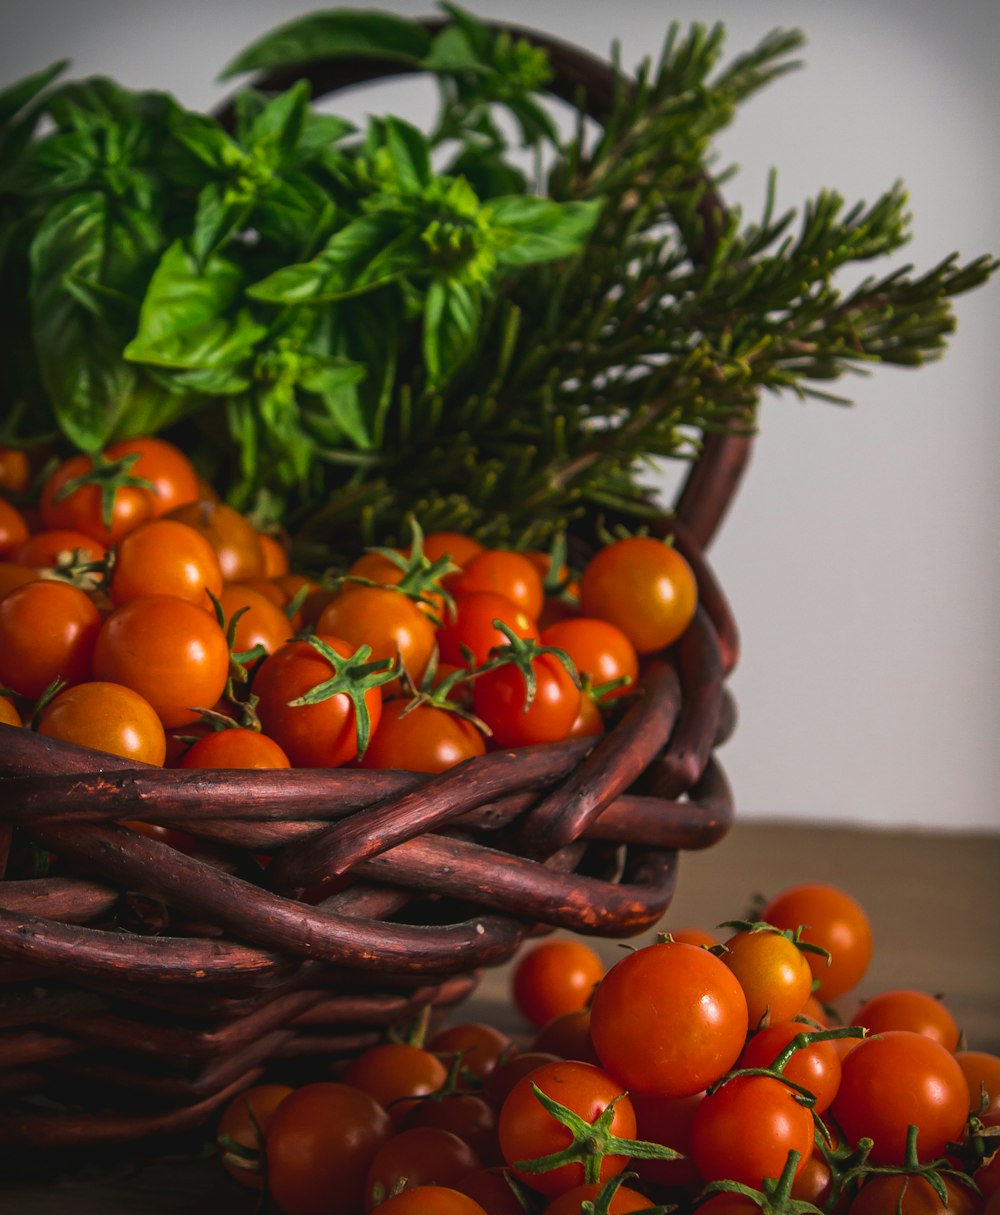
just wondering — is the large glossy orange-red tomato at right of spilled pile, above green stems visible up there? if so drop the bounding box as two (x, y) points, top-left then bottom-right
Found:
(831, 1029), (968, 1164)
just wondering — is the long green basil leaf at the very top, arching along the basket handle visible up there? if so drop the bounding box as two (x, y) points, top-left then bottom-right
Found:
(220, 9), (430, 80)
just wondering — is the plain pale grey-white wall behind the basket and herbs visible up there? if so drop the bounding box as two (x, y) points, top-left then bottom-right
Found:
(0, 0), (1000, 831)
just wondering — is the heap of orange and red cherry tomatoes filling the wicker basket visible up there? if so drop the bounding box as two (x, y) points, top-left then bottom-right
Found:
(0, 437), (697, 772)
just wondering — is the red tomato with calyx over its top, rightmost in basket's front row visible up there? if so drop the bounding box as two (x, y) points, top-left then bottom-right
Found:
(473, 654), (582, 747)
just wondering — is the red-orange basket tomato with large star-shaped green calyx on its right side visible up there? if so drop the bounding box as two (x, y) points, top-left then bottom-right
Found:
(253, 634), (382, 768)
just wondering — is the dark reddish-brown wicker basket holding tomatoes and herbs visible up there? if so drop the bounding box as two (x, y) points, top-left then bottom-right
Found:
(0, 23), (750, 1149)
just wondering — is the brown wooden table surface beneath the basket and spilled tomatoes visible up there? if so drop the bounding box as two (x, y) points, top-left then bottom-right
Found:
(0, 823), (1000, 1215)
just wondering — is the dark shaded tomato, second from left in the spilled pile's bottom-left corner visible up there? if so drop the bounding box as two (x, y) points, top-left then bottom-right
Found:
(266, 1081), (392, 1215)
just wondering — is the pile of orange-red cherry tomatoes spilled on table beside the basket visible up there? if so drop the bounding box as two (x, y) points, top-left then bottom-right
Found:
(211, 885), (1000, 1215)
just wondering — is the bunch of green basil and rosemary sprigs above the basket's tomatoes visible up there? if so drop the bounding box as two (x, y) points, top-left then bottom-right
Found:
(0, 5), (996, 552)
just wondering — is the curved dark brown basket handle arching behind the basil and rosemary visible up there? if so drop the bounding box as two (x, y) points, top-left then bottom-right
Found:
(215, 18), (752, 548)
